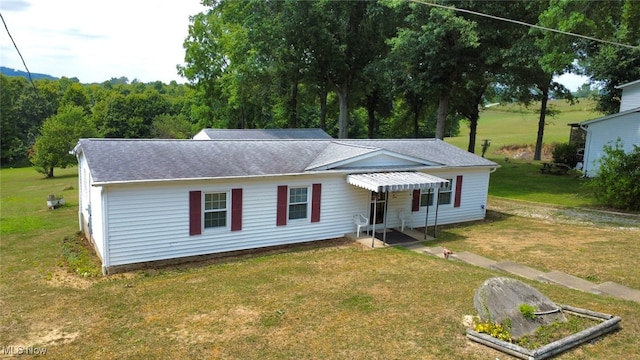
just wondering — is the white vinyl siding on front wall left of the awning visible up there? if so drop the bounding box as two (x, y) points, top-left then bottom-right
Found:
(103, 174), (368, 266)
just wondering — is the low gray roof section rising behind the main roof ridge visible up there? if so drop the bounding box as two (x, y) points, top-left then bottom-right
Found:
(202, 129), (332, 140)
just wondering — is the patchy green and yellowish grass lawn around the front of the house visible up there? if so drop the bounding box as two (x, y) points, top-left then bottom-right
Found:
(0, 167), (640, 360)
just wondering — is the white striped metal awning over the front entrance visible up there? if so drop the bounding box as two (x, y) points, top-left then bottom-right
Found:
(347, 171), (449, 193)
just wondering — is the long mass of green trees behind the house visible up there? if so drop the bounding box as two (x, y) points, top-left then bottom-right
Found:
(0, 0), (640, 174)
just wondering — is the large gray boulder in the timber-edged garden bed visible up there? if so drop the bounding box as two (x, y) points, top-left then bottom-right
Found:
(473, 277), (567, 339)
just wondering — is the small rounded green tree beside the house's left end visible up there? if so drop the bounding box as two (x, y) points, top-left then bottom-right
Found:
(29, 105), (96, 178)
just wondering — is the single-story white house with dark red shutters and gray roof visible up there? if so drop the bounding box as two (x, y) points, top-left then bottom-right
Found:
(74, 138), (498, 274)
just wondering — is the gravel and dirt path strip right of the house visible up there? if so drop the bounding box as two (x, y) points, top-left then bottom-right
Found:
(488, 197), (640, 231)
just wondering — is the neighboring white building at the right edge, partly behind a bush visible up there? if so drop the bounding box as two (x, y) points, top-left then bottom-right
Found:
(578, 80), (640, 177)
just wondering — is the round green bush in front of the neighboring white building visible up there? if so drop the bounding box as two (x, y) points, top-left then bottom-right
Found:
(587, 139), (640, 211)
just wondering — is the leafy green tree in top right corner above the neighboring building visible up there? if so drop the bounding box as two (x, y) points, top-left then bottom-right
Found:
(539, 0), (640, 114)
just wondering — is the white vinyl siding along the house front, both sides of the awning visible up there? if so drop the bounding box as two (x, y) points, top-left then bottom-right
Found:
(92, 168), (489, 267)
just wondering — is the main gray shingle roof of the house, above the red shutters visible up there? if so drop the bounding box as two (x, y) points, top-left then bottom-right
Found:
(76, 139), (497, 183)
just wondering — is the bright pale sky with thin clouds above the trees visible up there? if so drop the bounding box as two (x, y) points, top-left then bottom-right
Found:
(0, 0), (587, 90)
